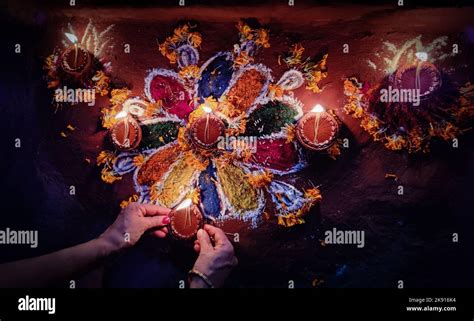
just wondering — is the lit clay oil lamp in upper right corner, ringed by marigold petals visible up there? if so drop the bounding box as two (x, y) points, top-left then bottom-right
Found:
(395, 51), (441, 99)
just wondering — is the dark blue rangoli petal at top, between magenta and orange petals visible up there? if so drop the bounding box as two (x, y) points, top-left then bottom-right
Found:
(196, 52), (234, 99)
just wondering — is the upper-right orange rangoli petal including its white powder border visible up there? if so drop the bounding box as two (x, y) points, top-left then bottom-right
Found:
(225, 65), (272, 114)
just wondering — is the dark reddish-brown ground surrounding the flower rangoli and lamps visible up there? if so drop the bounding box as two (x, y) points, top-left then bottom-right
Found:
(0, 2), (474, 287)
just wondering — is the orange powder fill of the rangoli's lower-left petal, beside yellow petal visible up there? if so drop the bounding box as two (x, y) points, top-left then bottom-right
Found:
(137, 145), (179, 186)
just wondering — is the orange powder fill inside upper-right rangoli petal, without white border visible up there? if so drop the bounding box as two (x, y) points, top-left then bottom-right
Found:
(227, 69), (265, 112)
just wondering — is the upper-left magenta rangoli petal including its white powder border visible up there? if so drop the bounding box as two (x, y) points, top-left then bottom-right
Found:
(145, 69), (194, 119)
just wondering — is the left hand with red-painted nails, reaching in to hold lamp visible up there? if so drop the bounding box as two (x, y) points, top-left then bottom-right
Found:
(99, 203), (171, 251)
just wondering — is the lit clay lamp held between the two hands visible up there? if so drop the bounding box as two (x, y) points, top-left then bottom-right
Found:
(169, 198), (204, 240)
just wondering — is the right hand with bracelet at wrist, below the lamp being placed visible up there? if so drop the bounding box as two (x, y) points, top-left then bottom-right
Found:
(190, 225), (238, 288)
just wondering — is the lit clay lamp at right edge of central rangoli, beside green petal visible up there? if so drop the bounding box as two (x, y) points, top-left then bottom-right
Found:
(296, 104), (339, 151)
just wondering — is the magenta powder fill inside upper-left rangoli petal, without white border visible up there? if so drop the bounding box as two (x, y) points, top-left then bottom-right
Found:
(150, 75), (193, 119)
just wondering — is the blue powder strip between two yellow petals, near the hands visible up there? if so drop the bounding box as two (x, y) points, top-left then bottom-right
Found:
(199, 164), (221, 218)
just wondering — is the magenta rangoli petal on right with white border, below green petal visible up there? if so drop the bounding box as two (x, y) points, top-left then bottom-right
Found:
(251, 134), (305, 174)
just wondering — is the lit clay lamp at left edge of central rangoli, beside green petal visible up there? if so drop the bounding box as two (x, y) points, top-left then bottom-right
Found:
(110, 110), (142, 150)
